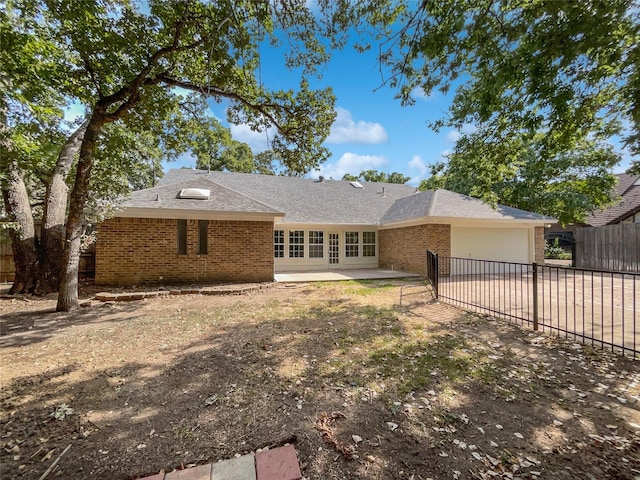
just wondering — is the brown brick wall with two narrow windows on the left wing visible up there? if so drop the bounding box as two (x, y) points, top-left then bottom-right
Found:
(95, 218), (274, 285)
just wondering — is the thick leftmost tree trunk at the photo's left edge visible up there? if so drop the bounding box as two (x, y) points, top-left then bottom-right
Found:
(2, 159), (39, 294)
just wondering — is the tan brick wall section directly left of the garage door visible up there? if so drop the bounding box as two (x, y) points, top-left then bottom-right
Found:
(378, 224), (451, 273)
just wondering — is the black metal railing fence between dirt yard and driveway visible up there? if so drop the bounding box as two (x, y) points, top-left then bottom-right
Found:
(427, 251), (640, 358)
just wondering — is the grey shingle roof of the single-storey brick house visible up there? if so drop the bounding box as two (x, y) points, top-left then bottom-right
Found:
(125, 169), (554, 225)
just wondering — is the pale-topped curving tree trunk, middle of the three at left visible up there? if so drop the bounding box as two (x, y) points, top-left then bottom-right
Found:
(39, 121), (88, 293)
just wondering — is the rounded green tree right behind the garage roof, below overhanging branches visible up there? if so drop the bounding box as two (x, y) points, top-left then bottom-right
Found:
(419, 134), (618, 224)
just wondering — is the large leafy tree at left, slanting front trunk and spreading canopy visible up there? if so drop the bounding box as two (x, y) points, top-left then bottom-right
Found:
(0, 0), (342, 310)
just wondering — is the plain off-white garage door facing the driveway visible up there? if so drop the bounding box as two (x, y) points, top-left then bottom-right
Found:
(451, 227), (530, 263)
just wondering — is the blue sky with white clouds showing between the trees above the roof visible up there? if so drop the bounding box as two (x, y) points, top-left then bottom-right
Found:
(165, 31), (631, 185)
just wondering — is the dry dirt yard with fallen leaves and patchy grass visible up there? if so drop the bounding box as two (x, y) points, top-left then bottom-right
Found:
(0, 281), (640, 480)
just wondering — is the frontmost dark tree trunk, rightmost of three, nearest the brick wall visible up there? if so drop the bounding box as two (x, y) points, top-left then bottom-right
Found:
(56, 115), (105, 312)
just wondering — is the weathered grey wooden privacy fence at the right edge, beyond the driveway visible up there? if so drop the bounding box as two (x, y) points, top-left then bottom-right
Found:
(574, 223), (640, 272)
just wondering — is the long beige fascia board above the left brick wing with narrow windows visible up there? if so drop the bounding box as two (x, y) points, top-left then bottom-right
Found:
(114, 207), (284, 223)
